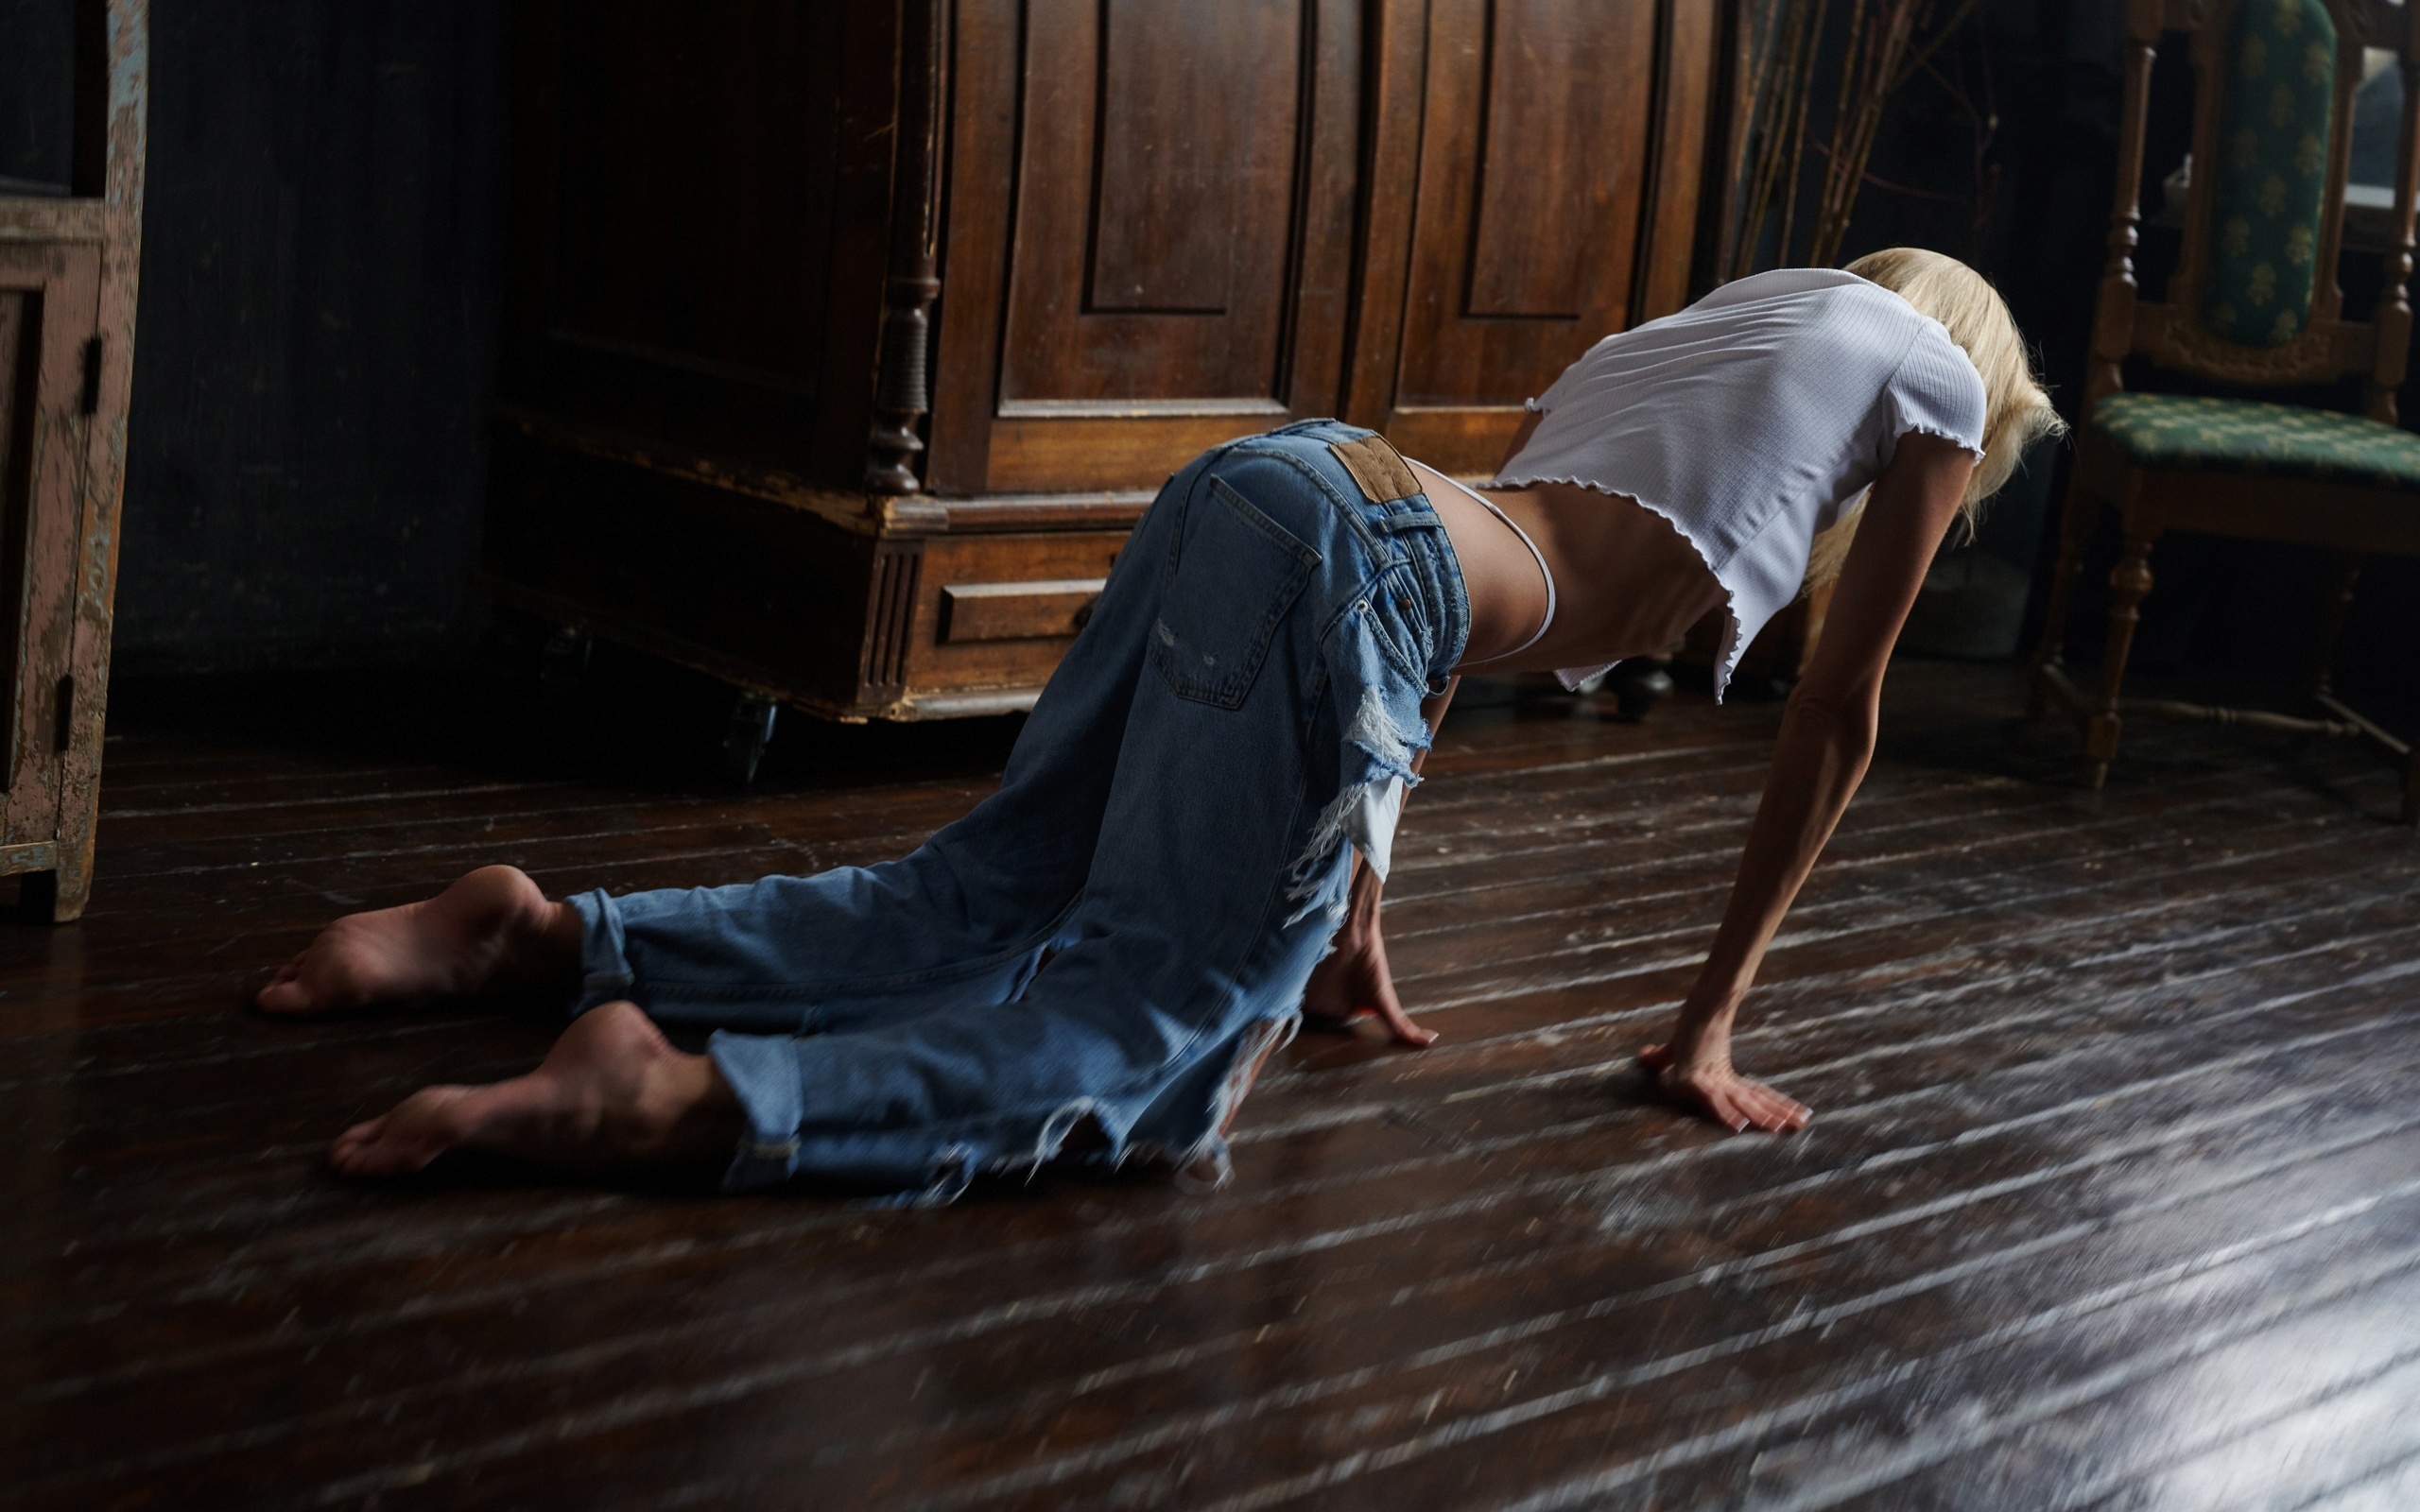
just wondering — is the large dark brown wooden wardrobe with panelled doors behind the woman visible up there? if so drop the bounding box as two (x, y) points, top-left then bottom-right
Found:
(487, 0), (1720, 721)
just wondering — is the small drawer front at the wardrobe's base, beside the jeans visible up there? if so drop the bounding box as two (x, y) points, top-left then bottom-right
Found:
(905, 530), (1125, 695)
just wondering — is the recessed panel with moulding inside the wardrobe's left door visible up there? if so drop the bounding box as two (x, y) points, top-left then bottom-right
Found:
(999, 0), (1302, 414)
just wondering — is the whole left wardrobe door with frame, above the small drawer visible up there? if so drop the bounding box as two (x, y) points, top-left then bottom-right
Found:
(934, 0), (1360, 493)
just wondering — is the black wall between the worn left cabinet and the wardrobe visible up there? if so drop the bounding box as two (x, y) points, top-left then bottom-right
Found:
(115, 0), (509, 673)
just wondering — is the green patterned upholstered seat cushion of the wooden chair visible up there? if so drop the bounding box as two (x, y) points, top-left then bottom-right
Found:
(2086, 394), (2420, 493)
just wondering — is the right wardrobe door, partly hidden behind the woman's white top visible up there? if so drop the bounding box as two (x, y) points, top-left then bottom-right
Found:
(1353, 0), (1716, 472)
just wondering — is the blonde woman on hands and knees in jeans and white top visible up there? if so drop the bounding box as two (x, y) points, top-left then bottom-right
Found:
(259, 249), (2057, 1200)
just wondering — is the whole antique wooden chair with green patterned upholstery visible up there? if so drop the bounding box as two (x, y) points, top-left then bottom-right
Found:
(2028, 0), (2420, 822)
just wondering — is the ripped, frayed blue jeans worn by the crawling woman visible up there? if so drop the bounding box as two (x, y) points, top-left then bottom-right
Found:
(571, 421), (1469, 1200)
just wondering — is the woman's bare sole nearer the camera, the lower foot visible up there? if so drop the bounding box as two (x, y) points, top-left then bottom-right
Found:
(327, 1002), (745, 1176)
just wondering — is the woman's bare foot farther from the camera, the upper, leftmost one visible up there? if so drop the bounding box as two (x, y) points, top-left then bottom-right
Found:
(256, 866), (580, 1014)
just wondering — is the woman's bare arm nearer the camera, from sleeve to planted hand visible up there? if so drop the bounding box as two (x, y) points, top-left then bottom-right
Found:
(1641, 433), (1975, 1132)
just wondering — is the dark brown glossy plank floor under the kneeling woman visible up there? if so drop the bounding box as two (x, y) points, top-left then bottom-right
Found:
(0, 662), (2420, 1512)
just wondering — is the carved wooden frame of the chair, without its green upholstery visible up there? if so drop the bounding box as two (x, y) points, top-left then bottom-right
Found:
(2028, 0), (2420, 822)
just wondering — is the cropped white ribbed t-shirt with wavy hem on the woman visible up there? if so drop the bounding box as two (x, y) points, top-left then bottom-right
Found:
(1495, 268), (1989, 699)
